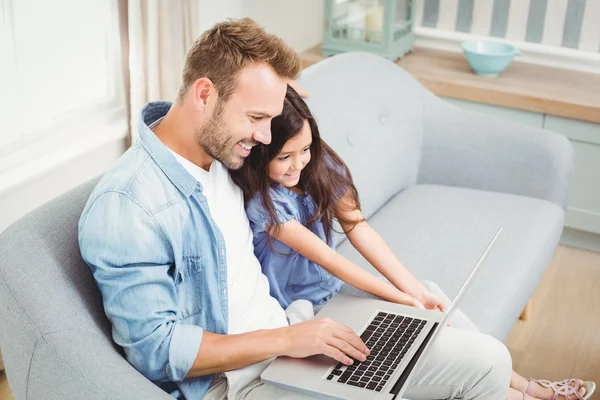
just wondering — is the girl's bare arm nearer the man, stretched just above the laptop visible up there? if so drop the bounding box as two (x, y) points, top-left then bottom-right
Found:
(267, 219), (424, 308)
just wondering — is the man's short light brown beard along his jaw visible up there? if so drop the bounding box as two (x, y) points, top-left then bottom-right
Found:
(196, 105), (245, 169)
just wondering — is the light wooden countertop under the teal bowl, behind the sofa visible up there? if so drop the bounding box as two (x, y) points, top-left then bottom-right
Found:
(300, 46), (600, 123)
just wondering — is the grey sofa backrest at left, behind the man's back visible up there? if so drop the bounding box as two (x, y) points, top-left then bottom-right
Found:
(0, 179), (115, 399)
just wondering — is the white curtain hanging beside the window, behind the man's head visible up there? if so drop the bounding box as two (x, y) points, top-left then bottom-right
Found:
(127, 0), (200, 143)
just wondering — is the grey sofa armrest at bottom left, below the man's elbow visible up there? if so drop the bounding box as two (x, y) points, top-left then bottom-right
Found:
(28, 329), (173, 400)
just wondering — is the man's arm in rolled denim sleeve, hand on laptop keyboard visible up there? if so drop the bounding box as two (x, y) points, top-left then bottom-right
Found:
(79, 192), (368, 382)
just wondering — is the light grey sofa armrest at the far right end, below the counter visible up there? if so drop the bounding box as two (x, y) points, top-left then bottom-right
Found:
(418, 92), (573, 208)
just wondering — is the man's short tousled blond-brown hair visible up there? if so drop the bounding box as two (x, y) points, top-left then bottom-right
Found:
(178, 18), (301, 101)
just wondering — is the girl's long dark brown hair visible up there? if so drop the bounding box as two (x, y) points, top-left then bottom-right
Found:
(230, 86), (361, 242)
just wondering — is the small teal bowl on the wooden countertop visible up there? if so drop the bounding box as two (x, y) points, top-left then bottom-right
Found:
(461, 40), (521, 76)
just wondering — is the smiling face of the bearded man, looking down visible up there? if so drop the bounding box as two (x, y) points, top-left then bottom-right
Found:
(196, 65), (287, 169)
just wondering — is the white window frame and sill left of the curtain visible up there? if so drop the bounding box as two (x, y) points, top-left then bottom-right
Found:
(0, 0), (129, 195)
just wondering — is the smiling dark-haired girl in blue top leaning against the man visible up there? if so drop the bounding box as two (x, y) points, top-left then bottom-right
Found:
(231, 87), (595, 400)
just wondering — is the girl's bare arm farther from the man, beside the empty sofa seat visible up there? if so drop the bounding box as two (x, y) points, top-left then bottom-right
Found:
(340, 195), (445, 311)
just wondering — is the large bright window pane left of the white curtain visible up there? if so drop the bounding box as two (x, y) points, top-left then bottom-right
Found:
(12, 0), (110, 136)
